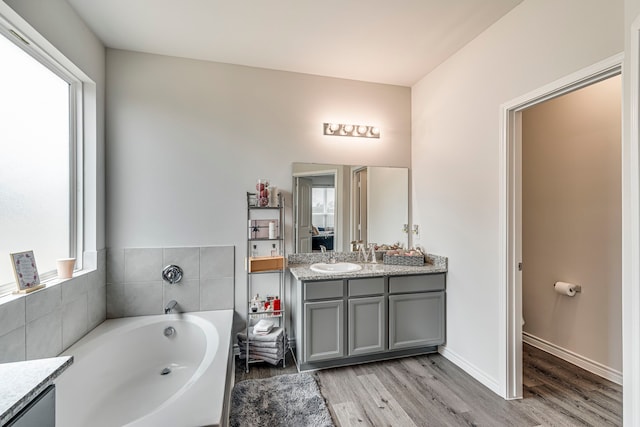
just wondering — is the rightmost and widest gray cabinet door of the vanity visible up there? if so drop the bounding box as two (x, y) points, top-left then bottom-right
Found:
(389, 291), (445, 350)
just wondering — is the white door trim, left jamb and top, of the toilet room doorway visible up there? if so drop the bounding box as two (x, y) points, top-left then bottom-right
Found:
(499, 54), (628, 399)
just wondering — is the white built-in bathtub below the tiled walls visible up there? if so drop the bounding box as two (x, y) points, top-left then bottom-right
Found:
(55, 310), (233, 427)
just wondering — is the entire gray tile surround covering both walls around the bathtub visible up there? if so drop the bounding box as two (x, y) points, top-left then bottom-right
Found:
(0, 246), (235, 363)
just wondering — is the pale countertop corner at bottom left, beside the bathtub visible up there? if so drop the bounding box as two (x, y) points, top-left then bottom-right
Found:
(0, 356), (73, 425)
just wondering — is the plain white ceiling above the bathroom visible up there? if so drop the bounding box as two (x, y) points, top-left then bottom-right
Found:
(67, 0), (522, 86)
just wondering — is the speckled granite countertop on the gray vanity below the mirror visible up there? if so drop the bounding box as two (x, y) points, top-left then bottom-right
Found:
(288, 253), (448, 281)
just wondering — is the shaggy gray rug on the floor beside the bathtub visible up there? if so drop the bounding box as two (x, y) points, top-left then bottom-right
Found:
(229, 374), (333, 427)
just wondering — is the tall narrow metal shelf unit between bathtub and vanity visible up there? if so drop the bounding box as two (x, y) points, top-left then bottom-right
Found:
(245, 192), (288, 373)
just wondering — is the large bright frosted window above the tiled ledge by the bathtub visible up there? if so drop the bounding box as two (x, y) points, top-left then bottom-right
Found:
(0, 26), (82, 295)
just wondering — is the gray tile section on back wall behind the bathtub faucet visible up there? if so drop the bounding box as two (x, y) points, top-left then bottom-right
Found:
(107, 246), (235, 318)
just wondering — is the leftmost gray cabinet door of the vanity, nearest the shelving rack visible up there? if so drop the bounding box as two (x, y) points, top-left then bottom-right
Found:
(304, 300), (344, 362)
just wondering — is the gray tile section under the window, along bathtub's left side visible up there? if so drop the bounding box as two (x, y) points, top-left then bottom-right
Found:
(0, 250), (106, 363)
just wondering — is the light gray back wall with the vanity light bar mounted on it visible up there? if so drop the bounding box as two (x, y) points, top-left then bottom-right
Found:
(107, 49), (411, 324)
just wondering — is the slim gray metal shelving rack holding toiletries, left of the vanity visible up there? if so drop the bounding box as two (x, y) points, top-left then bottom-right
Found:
(245, 192), (288, 373)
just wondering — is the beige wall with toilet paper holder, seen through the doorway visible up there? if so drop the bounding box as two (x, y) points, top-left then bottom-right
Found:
(522, 76), (622, 372)
